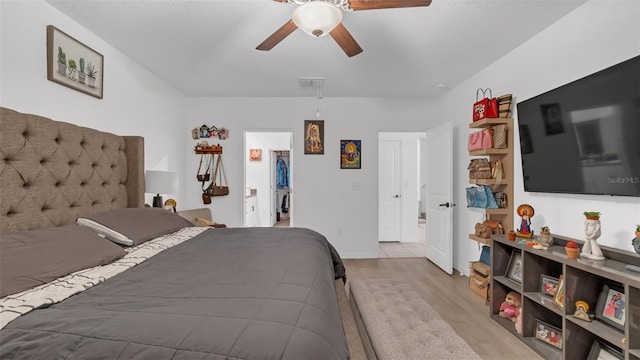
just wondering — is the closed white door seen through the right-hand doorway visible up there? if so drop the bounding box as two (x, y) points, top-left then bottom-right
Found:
(378, 139), (402, 241)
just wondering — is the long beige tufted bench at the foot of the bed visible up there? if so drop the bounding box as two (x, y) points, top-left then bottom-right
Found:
(349, 279), (480, 360)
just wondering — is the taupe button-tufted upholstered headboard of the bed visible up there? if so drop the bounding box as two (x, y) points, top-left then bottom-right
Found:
(0, 107), (144, 233)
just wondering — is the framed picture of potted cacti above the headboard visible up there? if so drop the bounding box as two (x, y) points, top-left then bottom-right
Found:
(47, 25), (104, 99)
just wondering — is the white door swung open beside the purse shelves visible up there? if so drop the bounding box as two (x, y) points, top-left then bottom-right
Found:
(426, 123), (454, 274)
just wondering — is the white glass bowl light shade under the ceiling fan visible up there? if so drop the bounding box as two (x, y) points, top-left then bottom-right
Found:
(291, 0), (342, 37)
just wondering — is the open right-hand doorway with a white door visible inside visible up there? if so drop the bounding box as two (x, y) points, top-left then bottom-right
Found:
(378, 132), (426, 257)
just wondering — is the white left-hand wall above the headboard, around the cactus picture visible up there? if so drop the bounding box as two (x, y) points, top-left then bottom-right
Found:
(0, 1), (188, 202)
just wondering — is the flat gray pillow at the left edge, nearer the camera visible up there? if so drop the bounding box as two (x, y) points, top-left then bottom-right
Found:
(0, 225), (126, 297)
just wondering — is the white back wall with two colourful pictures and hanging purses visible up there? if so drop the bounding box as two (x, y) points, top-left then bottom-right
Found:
(183, 97), (442, 258)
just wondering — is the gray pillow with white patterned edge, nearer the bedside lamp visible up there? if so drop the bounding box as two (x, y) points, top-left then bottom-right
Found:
(76, 208), (193, 246)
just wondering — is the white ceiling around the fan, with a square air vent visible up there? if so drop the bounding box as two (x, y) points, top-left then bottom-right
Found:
(47, 0), (585, 97)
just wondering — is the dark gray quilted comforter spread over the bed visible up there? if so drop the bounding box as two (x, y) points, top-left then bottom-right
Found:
(0, 228), (348, 360)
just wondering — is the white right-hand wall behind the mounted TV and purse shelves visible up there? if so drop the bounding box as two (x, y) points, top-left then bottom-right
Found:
(440, 1), (640, 273)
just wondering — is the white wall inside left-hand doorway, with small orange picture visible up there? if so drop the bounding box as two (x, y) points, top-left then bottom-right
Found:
(245, 132), (293, 227)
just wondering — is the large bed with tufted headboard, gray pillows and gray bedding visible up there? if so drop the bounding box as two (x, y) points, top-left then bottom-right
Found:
(0, 108), (361, 359)
